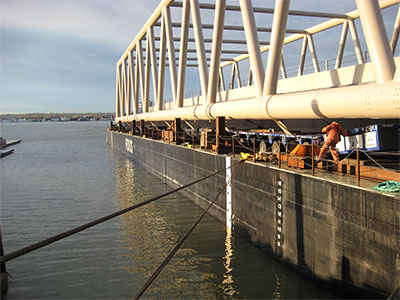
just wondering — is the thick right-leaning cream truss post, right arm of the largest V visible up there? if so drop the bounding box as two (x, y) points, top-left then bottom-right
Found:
(263, 0), (290, 96)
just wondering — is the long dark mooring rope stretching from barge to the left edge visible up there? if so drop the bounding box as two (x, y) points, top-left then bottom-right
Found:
(0, 162), (239, 263)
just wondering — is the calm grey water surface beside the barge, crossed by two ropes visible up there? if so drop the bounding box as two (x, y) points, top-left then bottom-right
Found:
(0, 122), (337, 299)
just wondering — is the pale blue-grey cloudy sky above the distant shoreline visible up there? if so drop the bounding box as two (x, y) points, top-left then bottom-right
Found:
(0, 0), (396, 113)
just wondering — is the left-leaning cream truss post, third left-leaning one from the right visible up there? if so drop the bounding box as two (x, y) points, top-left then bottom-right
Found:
(190, 0), (208, 103)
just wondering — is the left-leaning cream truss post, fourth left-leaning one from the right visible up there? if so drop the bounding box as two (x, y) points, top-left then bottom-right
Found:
(163, 7), (177, 107)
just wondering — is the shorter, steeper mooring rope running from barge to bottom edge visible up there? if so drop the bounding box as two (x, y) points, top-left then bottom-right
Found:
(134, 160), (244, 300)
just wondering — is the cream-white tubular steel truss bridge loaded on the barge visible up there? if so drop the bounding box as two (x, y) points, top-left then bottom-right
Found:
(116, 0), (400, 122)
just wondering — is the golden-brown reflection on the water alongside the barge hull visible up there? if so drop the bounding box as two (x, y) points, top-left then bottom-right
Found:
(113, 155), (335, 299)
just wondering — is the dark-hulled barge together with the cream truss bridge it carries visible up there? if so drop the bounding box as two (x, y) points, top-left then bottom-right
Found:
(108, 0), (400, 298)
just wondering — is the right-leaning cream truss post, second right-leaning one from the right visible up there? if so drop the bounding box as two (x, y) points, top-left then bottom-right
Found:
(207, 0), (226, 103)
